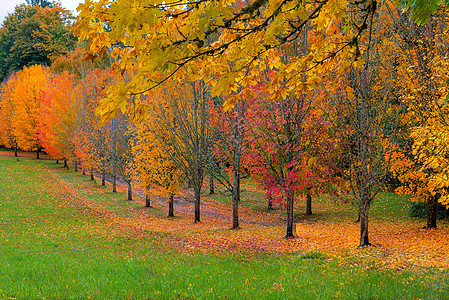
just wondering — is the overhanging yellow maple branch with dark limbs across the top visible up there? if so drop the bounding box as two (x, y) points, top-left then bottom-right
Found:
(74, 0), (377, 123)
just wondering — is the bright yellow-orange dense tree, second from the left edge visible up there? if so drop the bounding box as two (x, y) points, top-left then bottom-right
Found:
(12, 65), (49, 158)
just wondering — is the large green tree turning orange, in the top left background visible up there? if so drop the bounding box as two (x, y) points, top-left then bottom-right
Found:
(0, 1), (75, 80)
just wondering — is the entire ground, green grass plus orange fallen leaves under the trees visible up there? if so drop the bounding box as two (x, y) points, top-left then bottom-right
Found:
(0, 152), (449, 299)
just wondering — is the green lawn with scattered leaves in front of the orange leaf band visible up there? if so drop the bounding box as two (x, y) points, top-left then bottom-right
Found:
(0, 155), (449, 299)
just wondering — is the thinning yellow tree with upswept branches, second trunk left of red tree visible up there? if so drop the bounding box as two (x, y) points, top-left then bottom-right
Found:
(147, 80), (212, 223)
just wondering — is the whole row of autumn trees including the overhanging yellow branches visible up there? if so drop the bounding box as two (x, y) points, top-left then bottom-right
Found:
(0, 0), (449, 246)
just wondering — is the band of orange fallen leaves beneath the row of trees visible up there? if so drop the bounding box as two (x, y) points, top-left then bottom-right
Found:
(7, 150), (449, 269)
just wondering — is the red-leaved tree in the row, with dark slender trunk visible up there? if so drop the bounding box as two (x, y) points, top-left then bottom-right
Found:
(246, 74), (336, 238)
